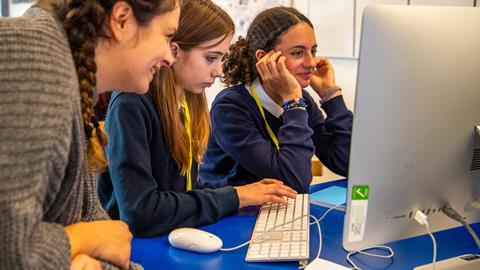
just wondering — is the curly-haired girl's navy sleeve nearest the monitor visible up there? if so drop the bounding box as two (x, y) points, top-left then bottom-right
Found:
(309, 96), (353, 176)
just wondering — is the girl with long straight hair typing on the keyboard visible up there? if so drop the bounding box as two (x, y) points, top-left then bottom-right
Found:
(97, 0), (295, 237)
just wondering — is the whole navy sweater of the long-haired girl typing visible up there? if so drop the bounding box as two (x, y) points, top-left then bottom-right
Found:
(97, 93), (239, 237)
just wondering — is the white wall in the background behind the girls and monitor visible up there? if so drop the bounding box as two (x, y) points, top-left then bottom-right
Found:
(6, 0), (480, 113)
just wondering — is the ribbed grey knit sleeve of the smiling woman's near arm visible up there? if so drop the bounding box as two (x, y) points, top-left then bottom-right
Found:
(0, 19), (72, 269)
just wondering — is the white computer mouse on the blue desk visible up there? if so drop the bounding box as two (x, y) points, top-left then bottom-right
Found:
(168, 228), (223, 253)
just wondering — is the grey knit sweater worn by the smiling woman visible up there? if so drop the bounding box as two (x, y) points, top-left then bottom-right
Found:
(0, 7), (141, 269)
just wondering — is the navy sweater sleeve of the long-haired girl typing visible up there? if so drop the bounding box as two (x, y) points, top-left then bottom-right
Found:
(100, 94), (239, 237)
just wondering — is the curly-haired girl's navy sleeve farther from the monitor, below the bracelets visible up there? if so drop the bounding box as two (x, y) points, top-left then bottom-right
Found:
(211, 93), (314, 192)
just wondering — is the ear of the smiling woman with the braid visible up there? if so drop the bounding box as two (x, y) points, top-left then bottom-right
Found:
(108, 1), (138, 41)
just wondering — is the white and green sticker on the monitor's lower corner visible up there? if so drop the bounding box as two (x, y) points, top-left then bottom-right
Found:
(348, 186), (370, 242)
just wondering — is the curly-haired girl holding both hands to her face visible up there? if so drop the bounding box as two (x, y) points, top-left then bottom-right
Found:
(200, 7), (353, 193)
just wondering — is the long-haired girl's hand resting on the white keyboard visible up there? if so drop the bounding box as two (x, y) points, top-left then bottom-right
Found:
(235, 178), (297, 208)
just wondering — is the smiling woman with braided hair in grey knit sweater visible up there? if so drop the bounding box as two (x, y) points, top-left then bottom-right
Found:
(0, 0), (180, 269)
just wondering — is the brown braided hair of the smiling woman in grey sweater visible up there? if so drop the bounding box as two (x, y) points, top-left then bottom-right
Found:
(45, 0), (181, 172)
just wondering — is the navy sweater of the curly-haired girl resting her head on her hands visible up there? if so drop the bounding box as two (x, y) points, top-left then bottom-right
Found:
(200, 85), (353, 193)
